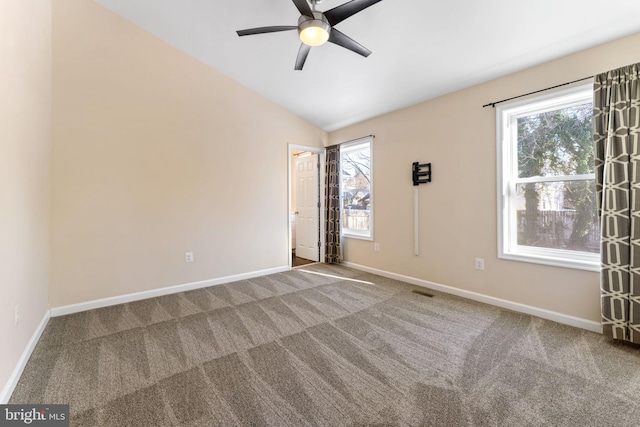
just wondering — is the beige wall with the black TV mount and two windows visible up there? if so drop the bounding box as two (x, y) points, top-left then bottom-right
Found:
(330, 34), (640, 321)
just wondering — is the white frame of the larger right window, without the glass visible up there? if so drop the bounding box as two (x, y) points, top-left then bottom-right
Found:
(496, 83), (600, 271)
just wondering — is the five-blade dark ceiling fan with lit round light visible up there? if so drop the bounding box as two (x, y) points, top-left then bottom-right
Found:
(236, 0), (381, 70)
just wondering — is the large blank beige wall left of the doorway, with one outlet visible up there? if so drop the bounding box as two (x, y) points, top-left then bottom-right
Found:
(51, 0), (327, 307)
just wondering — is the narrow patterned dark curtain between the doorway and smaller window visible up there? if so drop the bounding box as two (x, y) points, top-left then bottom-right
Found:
(325, 145), (341, 264)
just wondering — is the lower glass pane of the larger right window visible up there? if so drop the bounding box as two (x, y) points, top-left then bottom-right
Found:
(516, 180), (600, 253)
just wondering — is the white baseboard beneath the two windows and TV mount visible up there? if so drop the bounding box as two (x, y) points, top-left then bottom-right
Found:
(342, 262), (602, 334)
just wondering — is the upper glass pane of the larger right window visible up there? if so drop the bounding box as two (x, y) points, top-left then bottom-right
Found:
(517, 103), (595, 178)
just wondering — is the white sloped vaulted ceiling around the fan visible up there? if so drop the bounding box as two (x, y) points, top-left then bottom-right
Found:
(96, 0), (640, 131)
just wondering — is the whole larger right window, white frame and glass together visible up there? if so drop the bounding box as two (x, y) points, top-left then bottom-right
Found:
(497, 85), (600, 270)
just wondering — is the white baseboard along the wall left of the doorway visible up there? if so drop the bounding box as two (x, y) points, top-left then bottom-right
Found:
(51, 266), (291, 317)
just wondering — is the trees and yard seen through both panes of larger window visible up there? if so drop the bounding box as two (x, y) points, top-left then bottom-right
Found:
(516, 102), (599, 253)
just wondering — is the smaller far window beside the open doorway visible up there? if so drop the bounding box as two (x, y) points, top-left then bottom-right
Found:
(340, 136), (373, 240)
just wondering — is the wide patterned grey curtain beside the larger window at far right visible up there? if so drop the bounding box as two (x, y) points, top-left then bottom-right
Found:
(593, 64), (640, 344)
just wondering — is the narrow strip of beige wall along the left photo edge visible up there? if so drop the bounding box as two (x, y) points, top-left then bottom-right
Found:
(0, 0), (51, 398)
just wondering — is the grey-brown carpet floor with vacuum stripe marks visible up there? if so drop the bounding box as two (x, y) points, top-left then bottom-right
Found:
(10, 264), (640, 426)
